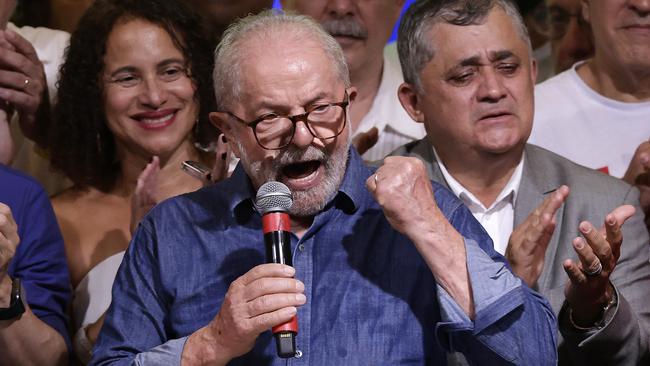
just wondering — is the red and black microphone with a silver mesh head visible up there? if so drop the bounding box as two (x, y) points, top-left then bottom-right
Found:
(255, 181), (298, 358)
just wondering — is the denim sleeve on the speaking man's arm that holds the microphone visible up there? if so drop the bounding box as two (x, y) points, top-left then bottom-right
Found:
(90, 222), (177, 365)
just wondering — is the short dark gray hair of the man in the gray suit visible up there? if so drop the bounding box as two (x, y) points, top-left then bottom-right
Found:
(397, 0), (533, 92)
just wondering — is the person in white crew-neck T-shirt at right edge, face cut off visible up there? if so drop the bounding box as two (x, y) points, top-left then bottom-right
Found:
(530, 0), (650, 212)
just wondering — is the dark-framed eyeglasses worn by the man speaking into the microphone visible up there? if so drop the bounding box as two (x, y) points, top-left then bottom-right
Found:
(226, 91), (350, 150)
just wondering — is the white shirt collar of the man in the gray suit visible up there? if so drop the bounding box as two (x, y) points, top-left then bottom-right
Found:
(432, 147), (524, 211)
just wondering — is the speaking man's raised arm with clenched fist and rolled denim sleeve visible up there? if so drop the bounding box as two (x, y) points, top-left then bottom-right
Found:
(366, 157), (557, 365)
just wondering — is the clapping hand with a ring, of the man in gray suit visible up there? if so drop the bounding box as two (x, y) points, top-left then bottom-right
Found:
(564, 205), (635, 325)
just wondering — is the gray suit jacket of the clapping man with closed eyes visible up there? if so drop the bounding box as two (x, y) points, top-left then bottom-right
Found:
(391, 139), (650, 365)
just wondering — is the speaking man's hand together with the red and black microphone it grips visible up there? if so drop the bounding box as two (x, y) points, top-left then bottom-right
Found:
(197, 182), (306, 363)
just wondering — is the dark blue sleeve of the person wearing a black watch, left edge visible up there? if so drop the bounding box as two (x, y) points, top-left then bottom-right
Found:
(8, 182), (72, 350)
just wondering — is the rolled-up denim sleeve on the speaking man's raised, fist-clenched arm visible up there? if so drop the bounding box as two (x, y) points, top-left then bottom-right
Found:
(436, 186), (557, 365)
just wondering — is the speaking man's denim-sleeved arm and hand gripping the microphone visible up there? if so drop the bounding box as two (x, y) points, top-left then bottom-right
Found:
(90, 219), (306, 365)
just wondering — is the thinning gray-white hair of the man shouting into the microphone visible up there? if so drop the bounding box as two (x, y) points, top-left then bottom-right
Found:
(212, 10), (350, 110)
